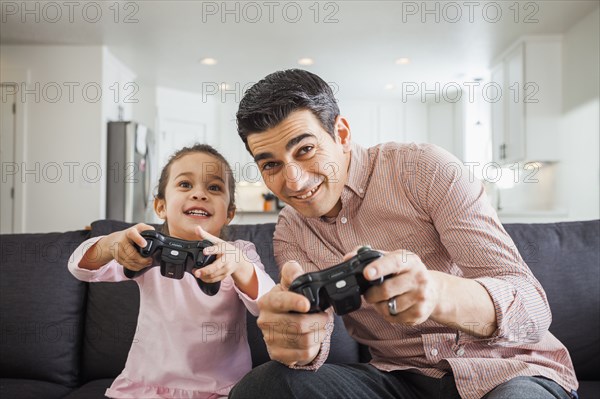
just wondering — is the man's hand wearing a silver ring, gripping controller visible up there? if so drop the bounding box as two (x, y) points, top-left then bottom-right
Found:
(358, 250), (440, 326)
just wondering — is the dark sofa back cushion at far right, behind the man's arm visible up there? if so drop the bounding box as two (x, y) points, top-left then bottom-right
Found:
(504, 220), (600, 380)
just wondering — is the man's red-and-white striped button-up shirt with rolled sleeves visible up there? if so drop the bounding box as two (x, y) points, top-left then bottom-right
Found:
(274, 143), (577, 398)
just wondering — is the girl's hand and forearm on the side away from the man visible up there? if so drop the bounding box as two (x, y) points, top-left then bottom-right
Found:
(79, 223), (154, 271)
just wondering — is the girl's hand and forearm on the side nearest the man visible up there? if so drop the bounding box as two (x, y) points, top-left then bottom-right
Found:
(193, 226), (258, 298)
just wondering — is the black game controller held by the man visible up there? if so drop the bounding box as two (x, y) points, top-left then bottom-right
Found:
(290, 247), (387, 316)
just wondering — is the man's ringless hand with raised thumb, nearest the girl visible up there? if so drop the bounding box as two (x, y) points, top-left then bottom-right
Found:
(257, 261), (329, 366)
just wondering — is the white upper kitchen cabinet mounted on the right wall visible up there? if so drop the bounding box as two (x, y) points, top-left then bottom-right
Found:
(486, 37), (562, 164)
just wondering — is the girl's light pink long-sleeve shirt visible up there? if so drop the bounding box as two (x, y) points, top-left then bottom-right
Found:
(68, 237), (275, 398)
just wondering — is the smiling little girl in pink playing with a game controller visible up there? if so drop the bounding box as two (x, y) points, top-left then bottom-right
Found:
(69, 144), (275, 398)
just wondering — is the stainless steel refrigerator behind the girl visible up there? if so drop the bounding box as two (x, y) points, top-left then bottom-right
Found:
(106, 121), (156, 223)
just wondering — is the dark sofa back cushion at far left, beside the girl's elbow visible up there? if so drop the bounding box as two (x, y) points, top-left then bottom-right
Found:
(0, 231), (88, 390)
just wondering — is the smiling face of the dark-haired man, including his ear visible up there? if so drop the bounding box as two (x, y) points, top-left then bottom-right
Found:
(248, 110), (350, 217)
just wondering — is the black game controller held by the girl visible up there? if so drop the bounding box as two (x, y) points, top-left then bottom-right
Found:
(123, 230), (221, 296)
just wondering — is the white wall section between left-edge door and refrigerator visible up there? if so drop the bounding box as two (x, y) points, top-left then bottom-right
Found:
(0, 45), (104, 232)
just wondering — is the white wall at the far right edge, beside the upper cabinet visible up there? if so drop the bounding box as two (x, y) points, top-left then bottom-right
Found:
(557, 8), (600, 220)
